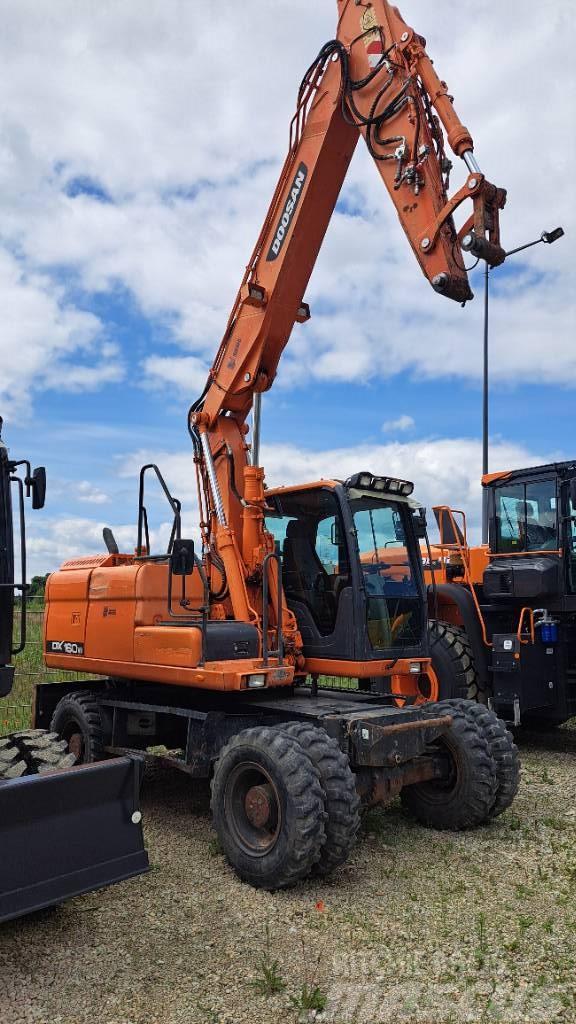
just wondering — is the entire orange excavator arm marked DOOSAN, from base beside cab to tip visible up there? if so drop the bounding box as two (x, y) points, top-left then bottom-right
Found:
(183, 0), (506, 660)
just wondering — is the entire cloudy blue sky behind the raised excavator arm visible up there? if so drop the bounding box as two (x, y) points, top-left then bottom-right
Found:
(0, 0), (576, 571)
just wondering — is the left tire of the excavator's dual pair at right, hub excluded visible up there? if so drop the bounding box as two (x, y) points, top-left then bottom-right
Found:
(400, 700), (498, 831)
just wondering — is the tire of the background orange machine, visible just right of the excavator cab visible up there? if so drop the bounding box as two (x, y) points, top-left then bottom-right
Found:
(428, 622), (486, 705)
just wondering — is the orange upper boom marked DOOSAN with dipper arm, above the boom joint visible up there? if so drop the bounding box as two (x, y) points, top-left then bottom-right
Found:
(198, 0), (505, 423)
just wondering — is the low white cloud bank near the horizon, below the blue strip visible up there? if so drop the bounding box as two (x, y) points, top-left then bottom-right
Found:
(28, 425), (566, 575)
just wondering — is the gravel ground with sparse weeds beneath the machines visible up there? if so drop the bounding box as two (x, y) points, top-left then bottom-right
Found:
(0, 730), (576, 1024)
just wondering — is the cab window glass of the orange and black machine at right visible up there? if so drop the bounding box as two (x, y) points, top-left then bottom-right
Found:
(495, 479), (559, 554)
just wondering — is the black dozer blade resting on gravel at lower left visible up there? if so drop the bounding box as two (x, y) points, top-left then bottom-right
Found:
(0, 758), (149, 922)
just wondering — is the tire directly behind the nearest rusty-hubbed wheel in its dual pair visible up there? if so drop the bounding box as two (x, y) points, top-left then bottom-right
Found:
(281, 722), (360, 877)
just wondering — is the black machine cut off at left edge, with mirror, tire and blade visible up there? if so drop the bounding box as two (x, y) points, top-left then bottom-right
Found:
(0, 418), (149, 923)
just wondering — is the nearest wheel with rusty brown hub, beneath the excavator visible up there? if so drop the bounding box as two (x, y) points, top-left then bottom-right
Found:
(211, 727), (326, 890)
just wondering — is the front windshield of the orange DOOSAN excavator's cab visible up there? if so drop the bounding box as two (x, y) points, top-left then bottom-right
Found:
(349, 498), (423, 650)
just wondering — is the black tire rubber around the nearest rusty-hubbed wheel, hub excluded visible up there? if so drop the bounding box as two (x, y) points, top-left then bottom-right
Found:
(211, 726), (327, 891)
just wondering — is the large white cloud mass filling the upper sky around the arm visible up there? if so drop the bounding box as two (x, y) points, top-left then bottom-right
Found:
(0, 0), (576, 415)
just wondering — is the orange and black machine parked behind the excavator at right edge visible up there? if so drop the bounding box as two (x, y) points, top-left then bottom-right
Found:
(425, 462), (576, 728)
